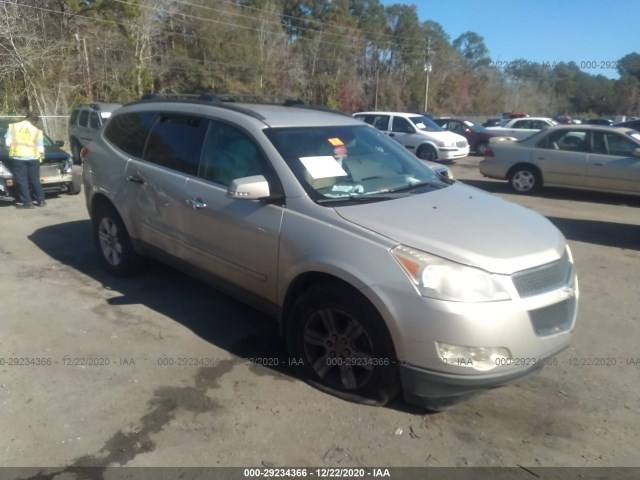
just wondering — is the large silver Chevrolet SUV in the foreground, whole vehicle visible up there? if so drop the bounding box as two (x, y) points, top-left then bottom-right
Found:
(83, 93), (578, 410)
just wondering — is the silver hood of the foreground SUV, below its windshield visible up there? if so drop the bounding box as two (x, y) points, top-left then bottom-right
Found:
(336, 183), (566, 275)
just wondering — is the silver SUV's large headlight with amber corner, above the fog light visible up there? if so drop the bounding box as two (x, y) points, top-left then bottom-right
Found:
(391, 245), (510, 302)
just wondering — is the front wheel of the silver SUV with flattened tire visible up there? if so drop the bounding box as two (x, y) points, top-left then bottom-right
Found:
(288, 284), (400, 405)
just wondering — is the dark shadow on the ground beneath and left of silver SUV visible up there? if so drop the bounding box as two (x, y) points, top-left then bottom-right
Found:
(29, 220), (424, 413)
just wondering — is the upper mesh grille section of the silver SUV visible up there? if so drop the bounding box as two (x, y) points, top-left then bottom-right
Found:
(511, 252), (573, 298)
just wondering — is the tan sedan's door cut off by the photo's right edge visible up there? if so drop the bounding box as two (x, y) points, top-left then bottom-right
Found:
(585, 131), (640, 194)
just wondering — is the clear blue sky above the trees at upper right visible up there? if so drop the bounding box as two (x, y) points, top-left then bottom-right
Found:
(383, 0), (640, 78)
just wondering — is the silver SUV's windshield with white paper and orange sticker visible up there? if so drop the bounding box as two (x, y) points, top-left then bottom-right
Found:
(265, 125), (448, 203)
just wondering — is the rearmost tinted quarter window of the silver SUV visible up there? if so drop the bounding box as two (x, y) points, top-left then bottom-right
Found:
(104, 112), (155, 158)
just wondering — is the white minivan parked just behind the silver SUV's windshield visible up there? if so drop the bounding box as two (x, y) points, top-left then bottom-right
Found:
(353, 112), (469, 162)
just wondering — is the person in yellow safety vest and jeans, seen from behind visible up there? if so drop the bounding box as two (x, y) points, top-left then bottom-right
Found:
(5, 112), (46, 208)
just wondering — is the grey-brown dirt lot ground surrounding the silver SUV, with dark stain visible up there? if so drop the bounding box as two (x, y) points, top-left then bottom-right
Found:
(0, 157), (640, 478)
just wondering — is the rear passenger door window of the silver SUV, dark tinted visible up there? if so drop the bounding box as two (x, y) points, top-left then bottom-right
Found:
(142, 114), (209, 175)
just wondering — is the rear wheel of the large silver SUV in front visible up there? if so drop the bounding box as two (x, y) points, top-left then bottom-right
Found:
(92, 205), (145, 277)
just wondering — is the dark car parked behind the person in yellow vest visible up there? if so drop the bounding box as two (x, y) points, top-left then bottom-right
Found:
(0, 118), (82, 198)
